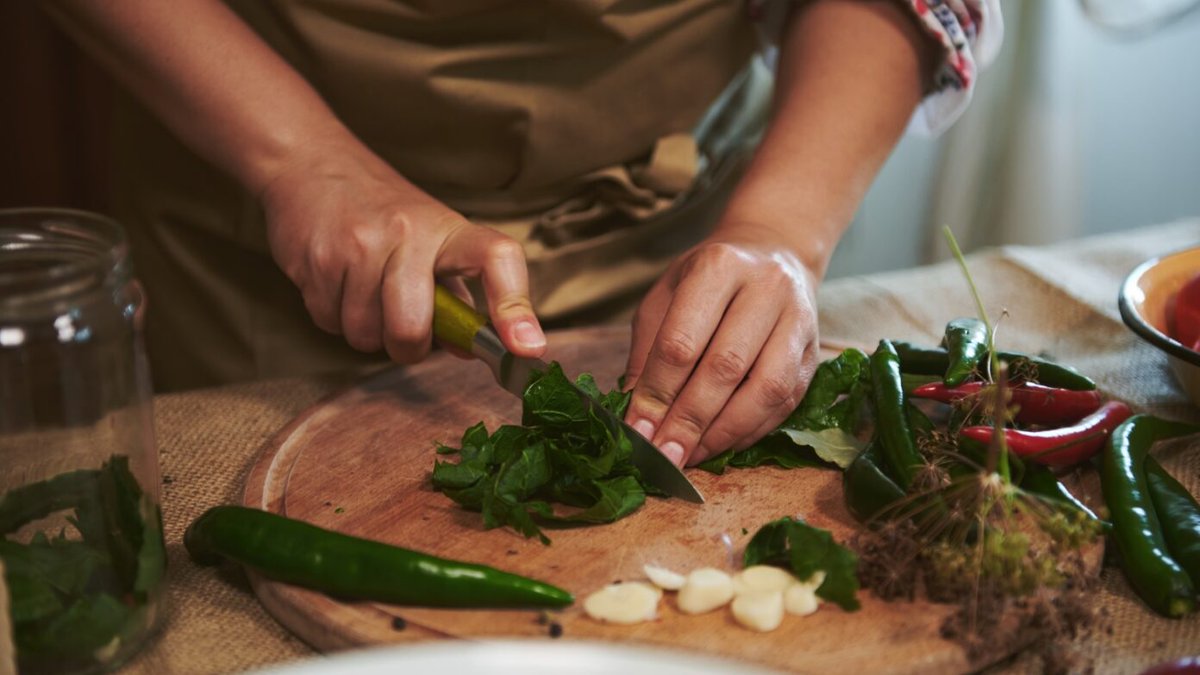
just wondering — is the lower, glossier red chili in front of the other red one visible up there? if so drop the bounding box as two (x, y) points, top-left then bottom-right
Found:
(959, 401), (1133, 466)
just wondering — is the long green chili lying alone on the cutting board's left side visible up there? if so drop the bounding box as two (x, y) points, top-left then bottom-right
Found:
(184, 506), (574, 608)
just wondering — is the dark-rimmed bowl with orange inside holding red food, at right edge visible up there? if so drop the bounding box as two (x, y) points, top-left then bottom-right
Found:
(1117, 246), (1200, 405)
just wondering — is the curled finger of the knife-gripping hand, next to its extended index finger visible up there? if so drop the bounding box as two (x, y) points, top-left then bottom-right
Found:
(380, 250), (433, 363)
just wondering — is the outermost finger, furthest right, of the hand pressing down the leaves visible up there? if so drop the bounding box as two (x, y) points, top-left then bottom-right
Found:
(688, 319), (816, 465)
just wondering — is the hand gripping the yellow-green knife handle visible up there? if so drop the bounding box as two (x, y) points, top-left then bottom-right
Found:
(260, 143), (546, 363)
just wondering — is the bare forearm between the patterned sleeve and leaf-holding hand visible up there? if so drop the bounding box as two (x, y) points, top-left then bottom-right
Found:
(719, 0), (934, 276)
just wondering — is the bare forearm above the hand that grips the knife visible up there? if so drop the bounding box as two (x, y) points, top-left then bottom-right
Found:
(44, 0), (355, 193)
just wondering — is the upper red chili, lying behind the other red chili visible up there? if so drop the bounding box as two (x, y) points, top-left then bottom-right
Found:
(912, 382), (1104, 424)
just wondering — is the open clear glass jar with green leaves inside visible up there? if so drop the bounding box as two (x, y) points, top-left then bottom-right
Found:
(0, 209), (166, 674)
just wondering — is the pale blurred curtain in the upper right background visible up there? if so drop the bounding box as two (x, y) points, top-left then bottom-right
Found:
(924, 0), (1200, 261)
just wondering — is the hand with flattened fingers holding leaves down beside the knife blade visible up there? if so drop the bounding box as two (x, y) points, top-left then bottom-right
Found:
(626, 226), (817, 466)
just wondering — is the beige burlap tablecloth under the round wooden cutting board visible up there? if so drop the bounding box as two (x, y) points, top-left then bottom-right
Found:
(124, 220), (1200, 674)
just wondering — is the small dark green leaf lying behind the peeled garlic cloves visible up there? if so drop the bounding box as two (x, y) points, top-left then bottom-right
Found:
(743, 516), (859, 611)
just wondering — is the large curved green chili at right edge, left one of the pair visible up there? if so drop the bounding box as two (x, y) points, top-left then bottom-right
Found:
(1100, 414), (1198, 617)
